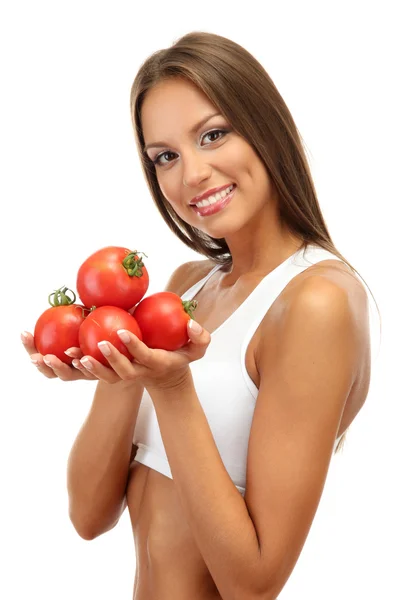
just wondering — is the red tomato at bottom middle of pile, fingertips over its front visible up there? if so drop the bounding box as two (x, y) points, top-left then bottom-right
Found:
(79, 306), (143, 367)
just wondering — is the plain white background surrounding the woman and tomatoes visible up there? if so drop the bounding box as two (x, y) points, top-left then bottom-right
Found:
(0, 0), (400, 600)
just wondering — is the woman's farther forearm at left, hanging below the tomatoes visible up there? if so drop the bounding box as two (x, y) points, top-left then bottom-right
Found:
(67, 382), (143, 538)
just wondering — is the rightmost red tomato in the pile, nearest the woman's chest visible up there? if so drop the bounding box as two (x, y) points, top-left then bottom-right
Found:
(132, 292), (197, 350)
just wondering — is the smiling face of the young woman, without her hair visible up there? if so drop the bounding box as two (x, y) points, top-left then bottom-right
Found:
(142, 79), (273, 238)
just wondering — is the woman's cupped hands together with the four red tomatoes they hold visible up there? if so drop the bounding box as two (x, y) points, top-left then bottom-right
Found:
(22, 246), (211, 389)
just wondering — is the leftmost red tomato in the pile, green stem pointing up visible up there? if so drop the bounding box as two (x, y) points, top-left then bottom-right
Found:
(33, 288), (87, 365)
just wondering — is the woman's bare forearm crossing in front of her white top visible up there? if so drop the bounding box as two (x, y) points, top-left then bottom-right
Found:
(149, 377), (260, 600)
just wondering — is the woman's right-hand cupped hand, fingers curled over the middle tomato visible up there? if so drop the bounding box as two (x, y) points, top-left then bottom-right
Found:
(88, 318), (211, 390)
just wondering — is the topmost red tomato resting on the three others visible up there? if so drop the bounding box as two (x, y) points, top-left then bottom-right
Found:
(76, 246), (149, 310)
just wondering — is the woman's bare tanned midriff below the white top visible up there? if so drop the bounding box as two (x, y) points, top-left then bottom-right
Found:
(127, 462), (221, 600)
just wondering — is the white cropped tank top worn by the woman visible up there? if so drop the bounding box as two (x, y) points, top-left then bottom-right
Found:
(133, 245), (368, 496)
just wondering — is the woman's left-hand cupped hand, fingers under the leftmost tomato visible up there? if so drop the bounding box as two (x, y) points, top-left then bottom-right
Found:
(21, 332), (98, 381)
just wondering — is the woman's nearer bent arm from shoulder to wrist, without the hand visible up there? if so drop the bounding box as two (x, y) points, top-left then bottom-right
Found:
(151, 278), (360, 600)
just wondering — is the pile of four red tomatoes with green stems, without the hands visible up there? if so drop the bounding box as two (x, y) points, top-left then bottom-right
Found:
(34, 246), (197, 366)
